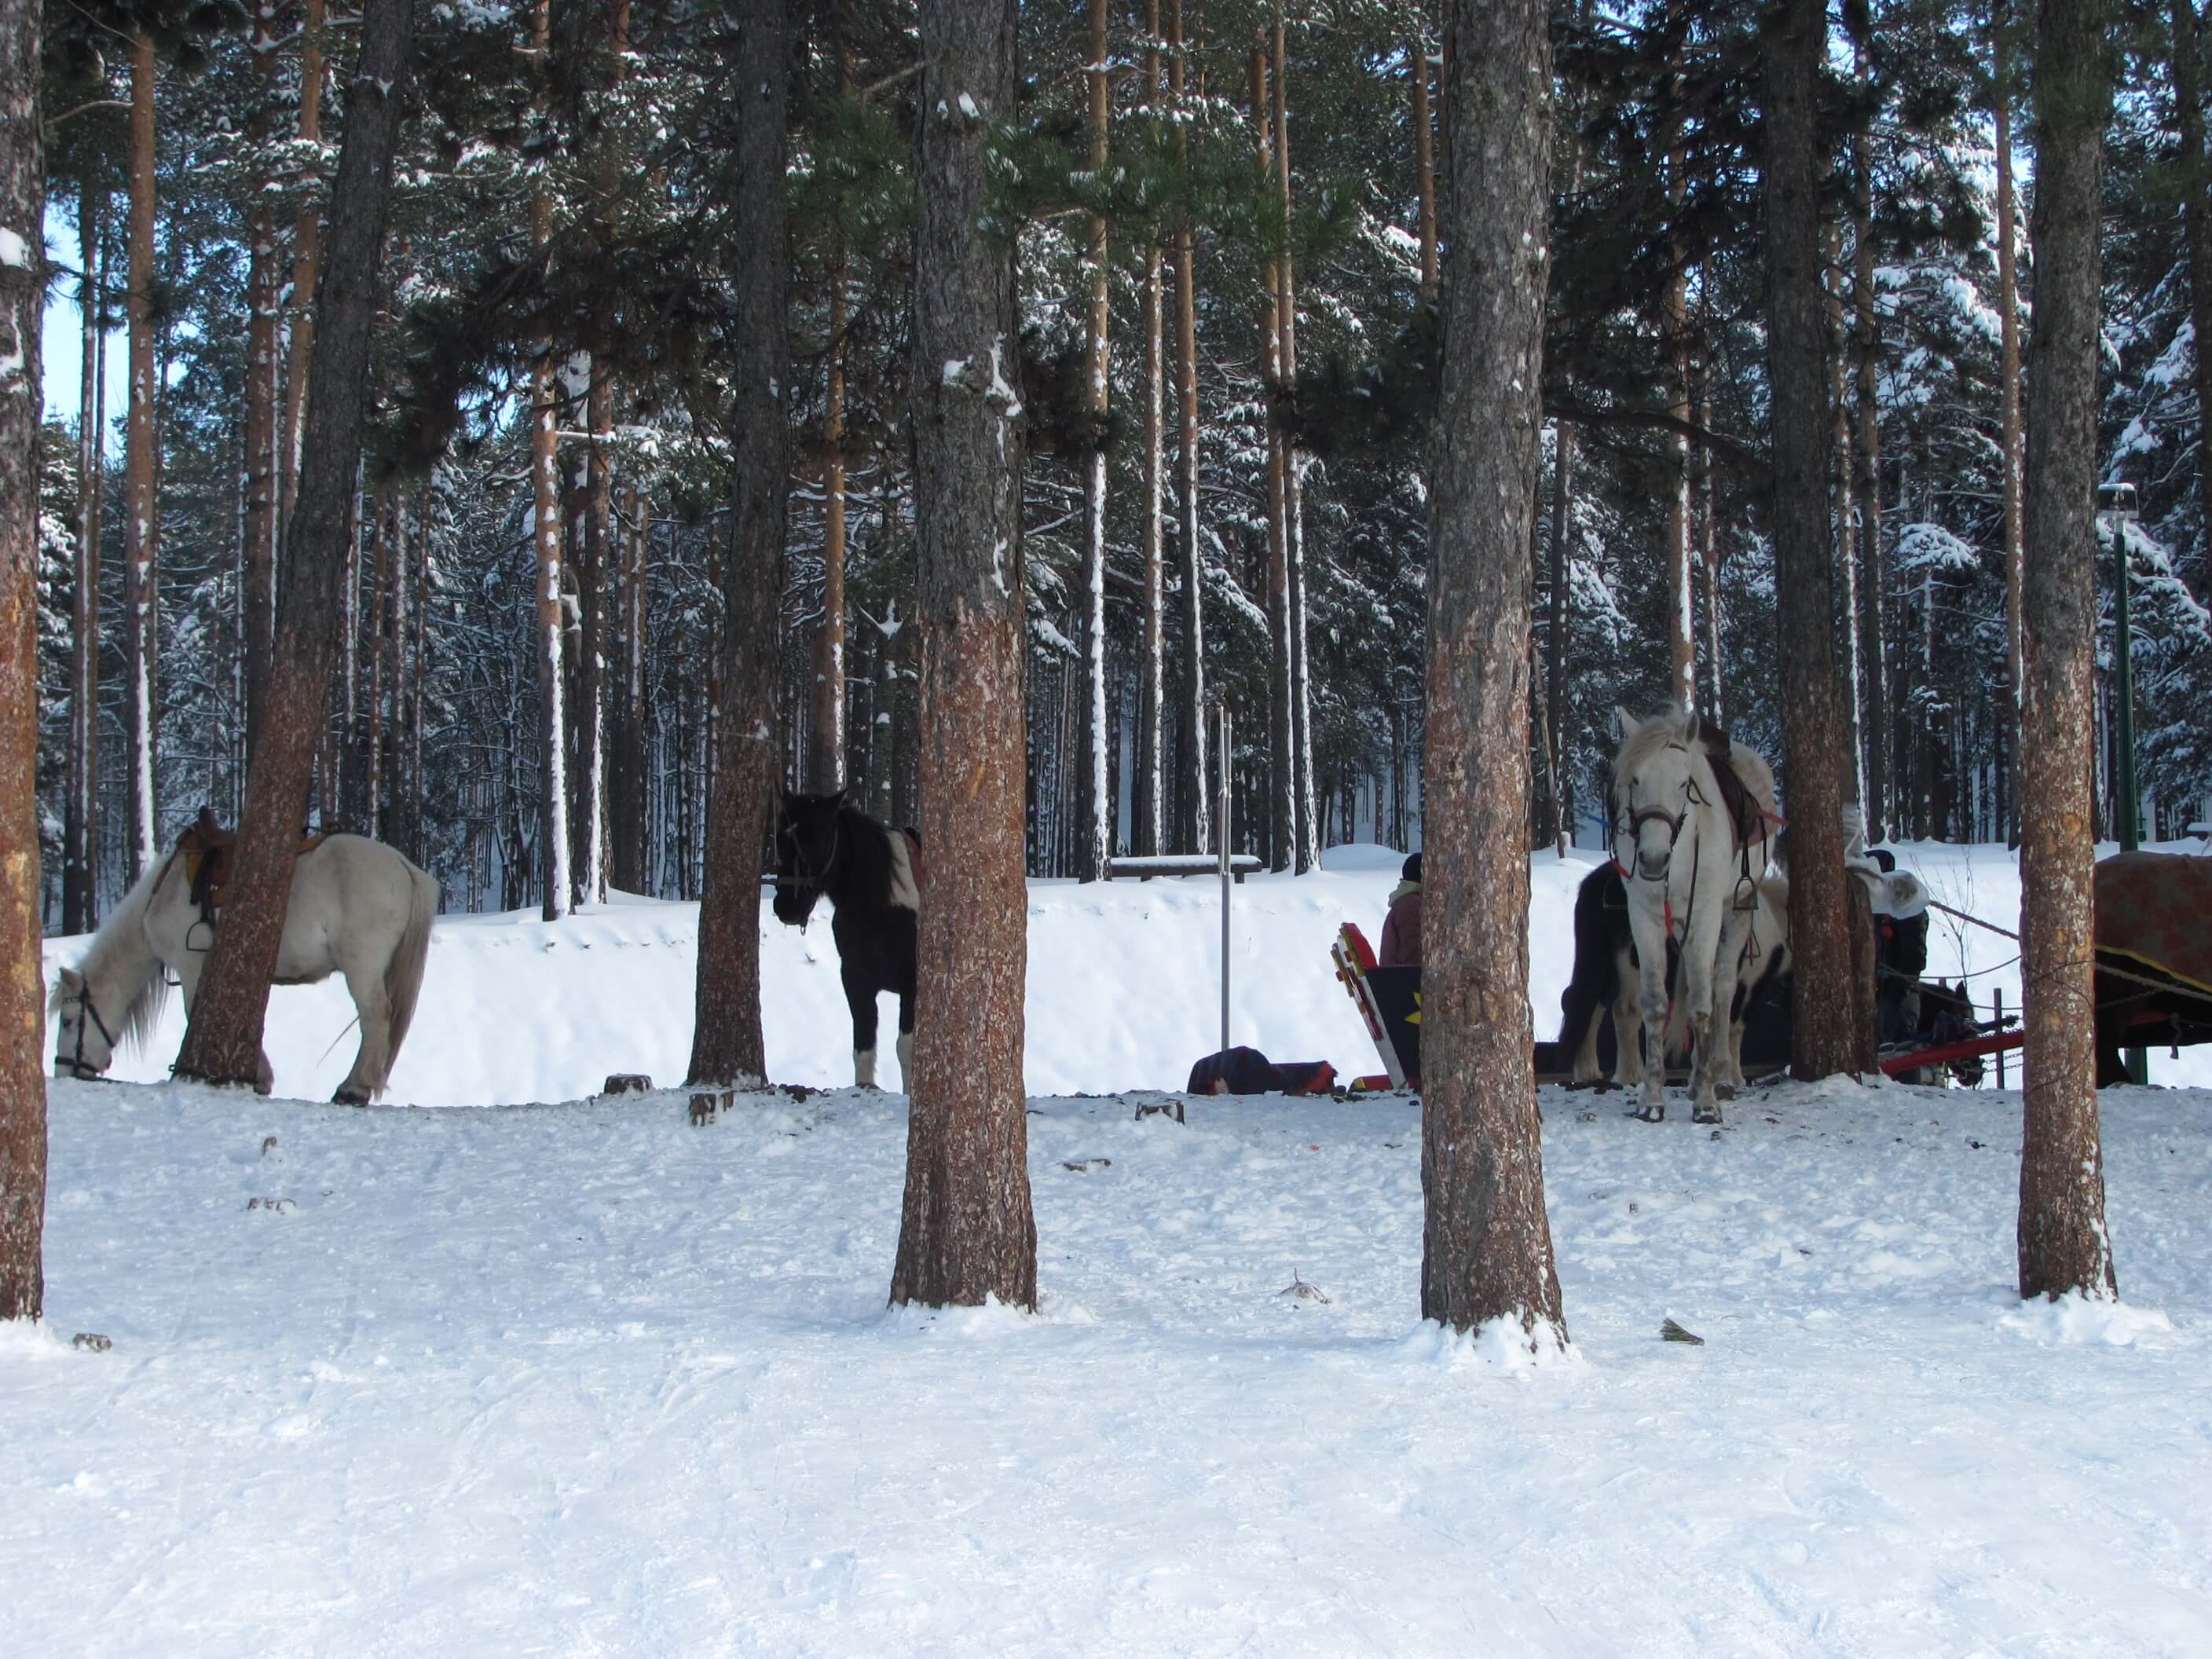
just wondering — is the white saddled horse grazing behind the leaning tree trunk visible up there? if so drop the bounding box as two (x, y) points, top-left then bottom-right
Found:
(49, 836), (438, 1106)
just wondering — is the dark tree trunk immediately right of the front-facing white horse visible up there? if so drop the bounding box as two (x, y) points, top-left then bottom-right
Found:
(1761, 0), (1858, 1079)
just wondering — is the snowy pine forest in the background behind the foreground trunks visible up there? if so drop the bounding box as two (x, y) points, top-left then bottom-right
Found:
(17, 0), (2212, 932)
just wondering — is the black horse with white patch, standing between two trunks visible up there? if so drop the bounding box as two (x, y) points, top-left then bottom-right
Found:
(776, 789), (922, 1088)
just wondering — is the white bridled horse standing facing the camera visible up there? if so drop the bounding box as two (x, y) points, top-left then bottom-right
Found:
(1613, 708), (1778, 1124)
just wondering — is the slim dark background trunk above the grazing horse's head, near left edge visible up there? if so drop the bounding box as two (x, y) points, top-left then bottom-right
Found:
(62, 188), (106, 933)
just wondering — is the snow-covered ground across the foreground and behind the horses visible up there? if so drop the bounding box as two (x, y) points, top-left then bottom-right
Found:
(17, 849), (2212, 1659)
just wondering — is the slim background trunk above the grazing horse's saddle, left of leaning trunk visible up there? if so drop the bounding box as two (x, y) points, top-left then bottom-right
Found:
(244, 0), (283, 754)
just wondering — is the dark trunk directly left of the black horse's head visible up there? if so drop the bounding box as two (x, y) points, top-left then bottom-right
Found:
(686, 0), (792, 1086)
